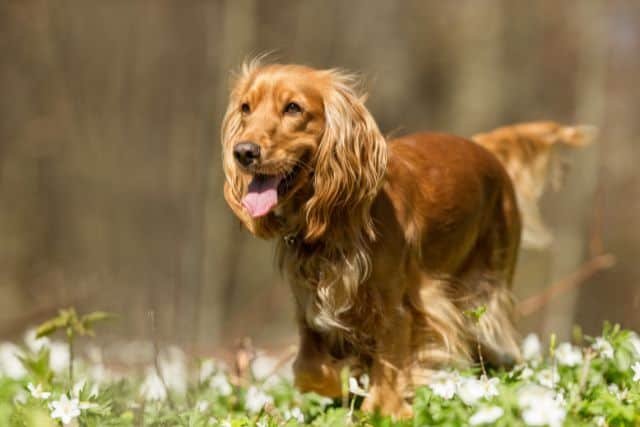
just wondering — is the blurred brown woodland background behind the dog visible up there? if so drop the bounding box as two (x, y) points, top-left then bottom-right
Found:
(0, 0), (640, 352)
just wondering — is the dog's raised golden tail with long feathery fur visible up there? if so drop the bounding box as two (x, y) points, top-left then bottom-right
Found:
(471, 122), (598, 249)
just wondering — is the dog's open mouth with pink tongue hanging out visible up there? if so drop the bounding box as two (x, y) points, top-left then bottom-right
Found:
(242, 166), (300, 218)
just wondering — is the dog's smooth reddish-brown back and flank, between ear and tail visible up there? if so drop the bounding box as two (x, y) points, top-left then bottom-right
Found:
(386, 132), (520, 281)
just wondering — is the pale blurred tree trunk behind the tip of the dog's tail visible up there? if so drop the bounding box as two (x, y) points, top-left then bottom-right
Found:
(544, 0), (608, 339)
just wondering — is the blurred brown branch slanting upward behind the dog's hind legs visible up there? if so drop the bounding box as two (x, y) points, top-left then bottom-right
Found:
(517, 254), (616, 316)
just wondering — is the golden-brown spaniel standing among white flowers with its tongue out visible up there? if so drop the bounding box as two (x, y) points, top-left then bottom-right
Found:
(222, 61), (596, 418)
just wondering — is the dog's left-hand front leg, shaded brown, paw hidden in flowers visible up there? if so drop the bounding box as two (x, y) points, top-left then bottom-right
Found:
(293, 324), (355, 397)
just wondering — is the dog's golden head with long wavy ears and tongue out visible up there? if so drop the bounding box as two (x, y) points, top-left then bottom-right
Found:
(222, 63), (387, 242)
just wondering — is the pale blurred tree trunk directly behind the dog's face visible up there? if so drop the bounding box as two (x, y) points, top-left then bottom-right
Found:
(195, 0), (257, 346)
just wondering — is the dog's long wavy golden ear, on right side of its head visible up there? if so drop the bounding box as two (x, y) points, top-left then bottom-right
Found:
(304, 70), (387, 242)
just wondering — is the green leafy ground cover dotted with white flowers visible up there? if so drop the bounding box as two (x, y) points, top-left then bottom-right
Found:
(0, 311), (640, 427)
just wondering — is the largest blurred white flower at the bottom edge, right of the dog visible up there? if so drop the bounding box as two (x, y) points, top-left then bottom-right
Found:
(518, 384), (566, 427)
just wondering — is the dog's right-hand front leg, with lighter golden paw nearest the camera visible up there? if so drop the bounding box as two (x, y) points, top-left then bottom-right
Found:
(362, 308), (413, 418)
